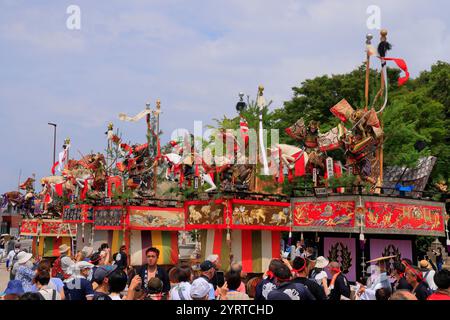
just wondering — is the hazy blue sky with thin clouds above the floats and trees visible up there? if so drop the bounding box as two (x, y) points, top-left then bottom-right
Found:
(0, 0), (450, 192)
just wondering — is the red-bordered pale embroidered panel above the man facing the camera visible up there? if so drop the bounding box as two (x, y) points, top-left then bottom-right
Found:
(127, 207), (184, 230)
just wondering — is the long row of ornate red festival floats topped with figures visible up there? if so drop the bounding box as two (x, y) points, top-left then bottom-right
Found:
(4, 30), (450, 281)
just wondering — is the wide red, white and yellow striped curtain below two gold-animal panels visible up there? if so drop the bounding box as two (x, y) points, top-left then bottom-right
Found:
(200, 229), (281, 273)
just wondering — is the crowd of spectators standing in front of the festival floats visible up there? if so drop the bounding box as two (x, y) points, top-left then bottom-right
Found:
(2, 239), (450, 301)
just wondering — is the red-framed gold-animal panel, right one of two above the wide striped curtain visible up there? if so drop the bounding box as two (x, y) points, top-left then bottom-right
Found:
(229, 199), (290, 231)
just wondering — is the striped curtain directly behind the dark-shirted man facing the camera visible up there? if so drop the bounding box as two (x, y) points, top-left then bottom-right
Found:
(130, 230), (178, 266)
